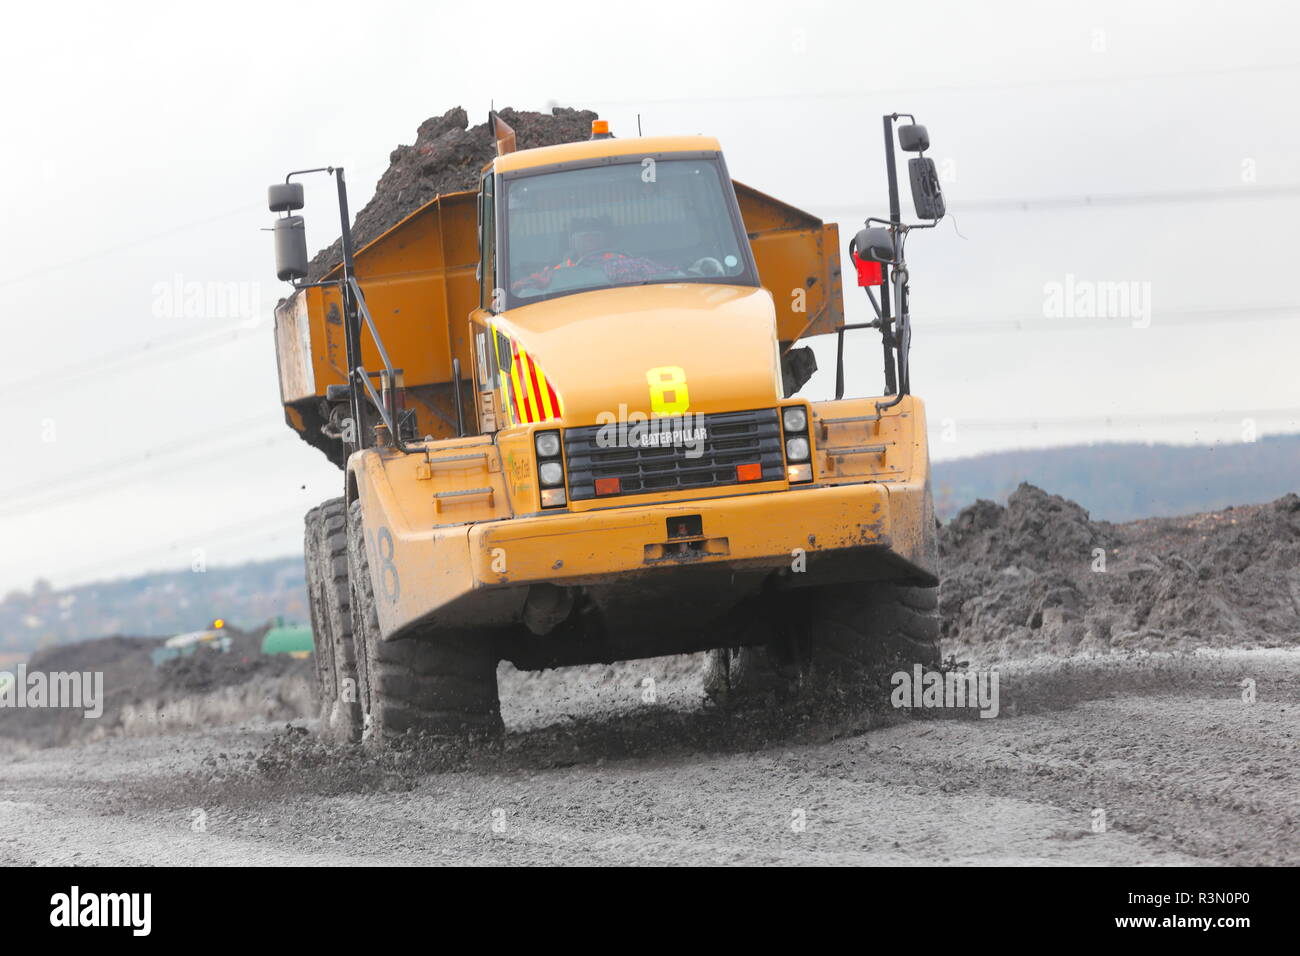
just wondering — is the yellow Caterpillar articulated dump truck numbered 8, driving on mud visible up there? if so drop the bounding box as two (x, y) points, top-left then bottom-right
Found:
(269, 113), (944, 743)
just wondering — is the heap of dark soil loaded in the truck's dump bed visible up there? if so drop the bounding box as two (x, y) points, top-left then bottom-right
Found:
(309, 107), (597, 282)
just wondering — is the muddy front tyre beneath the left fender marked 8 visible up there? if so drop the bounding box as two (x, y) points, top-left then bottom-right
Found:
(348, 502), (502, 745)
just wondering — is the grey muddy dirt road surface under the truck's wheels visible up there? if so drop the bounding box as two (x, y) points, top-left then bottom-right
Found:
(0, 650), (1300, 865)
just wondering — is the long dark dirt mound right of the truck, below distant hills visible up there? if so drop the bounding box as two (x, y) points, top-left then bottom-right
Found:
(940, 484), (1300, 657)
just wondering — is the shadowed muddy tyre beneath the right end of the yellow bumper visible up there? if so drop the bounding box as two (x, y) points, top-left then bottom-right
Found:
(705, 583), (941, 706)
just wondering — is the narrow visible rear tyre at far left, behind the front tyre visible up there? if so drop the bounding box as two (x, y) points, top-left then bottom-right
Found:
(303, 498), (361, 743)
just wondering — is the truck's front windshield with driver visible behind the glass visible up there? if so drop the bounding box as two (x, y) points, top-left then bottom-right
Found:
(504, 157), (757, 304)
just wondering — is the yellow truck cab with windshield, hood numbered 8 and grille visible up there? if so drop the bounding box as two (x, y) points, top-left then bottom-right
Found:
(471, 137), (785, 510)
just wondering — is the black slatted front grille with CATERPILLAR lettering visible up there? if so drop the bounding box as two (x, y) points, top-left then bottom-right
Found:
(564, 408), (785, 501)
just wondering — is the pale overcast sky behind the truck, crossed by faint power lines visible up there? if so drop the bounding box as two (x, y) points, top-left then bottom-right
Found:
(0, 0), (1300, 591)
